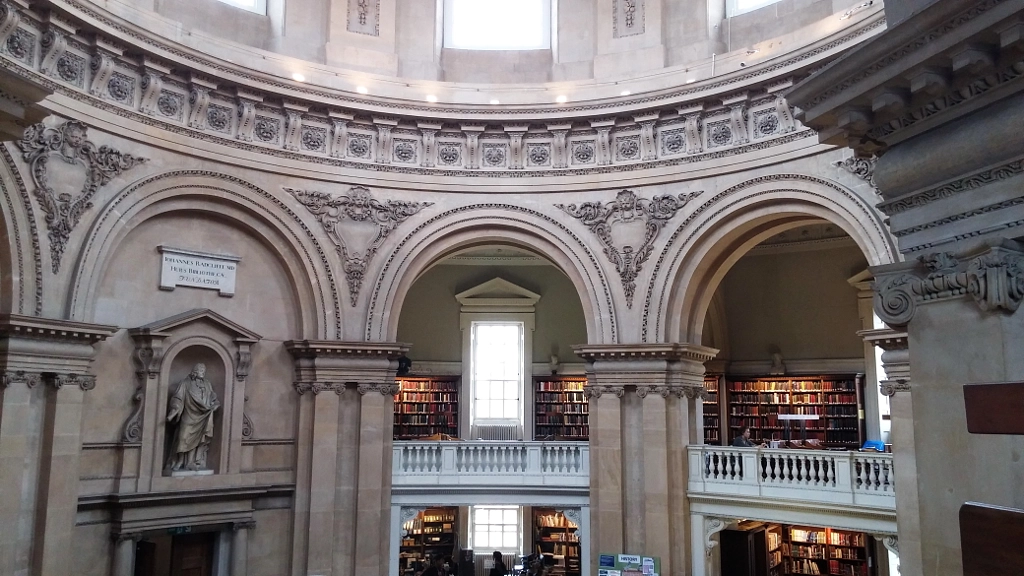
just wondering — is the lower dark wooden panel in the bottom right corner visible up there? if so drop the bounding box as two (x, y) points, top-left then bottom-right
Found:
(959, 502), (1024, 576)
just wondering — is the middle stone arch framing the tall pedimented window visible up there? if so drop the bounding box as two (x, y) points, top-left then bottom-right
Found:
(366, 204), (618, 343)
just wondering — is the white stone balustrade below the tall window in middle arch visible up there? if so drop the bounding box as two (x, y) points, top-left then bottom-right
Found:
(391, 441), (590, 488)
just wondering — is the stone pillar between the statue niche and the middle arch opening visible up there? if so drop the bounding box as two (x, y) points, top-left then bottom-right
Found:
(285, 340), (409, 576)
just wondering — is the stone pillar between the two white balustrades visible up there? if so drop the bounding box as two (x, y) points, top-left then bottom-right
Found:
(577, 344), (717, 575)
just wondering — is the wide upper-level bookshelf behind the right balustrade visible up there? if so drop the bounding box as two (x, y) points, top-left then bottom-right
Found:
(720, 375), (864, 449)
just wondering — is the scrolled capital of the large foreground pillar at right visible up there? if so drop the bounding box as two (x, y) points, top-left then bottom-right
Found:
(872, 240), (1024, 326)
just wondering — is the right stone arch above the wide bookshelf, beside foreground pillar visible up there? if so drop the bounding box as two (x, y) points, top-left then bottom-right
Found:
(643, 174), (898, 343)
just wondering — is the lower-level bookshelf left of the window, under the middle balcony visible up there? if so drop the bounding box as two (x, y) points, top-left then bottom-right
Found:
(398, 507), (459, 576)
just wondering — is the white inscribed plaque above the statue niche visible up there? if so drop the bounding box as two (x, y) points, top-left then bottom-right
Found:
(158, 246), (242, 296)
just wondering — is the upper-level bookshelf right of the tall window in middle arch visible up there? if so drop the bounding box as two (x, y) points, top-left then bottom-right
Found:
(534, 376), (590, 442)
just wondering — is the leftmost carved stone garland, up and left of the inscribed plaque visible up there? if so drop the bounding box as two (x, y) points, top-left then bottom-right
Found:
(17, 121), (146, 274)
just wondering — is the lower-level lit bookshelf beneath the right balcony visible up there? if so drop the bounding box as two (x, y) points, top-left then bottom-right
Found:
(782, 526), (873, 576)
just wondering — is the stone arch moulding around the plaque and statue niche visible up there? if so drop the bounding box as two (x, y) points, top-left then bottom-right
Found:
(67, 170), (342, 338)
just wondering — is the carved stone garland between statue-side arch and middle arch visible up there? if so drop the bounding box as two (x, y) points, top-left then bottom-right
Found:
(285, 187), (433, 306)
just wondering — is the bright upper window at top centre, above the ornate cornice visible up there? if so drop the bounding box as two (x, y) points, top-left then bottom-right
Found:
(444, 0), (551, 50)
